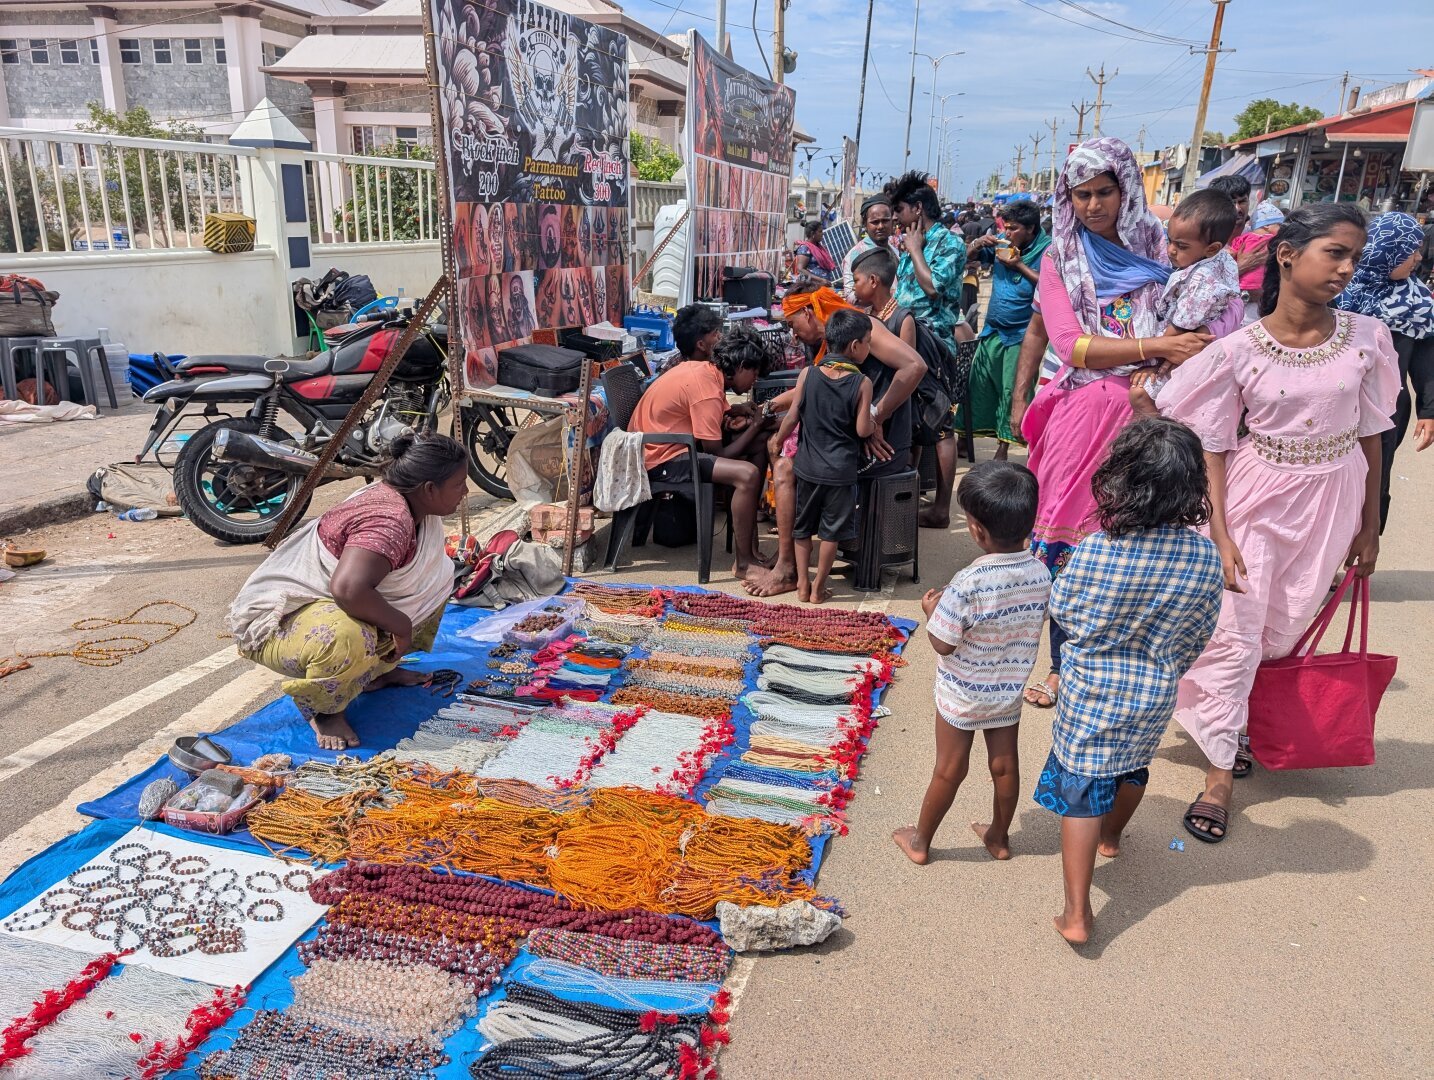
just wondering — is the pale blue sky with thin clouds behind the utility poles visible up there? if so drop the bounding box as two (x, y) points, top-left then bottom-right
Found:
(619, 0), (1434, 195)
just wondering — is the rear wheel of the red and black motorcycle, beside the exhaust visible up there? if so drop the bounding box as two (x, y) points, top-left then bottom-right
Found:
(175, 416), (308, 544)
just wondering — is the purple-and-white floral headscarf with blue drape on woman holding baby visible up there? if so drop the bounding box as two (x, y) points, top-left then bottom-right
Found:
(1050, 138), (1170, 386)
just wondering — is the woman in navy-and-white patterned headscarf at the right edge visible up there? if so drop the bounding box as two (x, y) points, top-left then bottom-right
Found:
(1335, 207), (1434, 532)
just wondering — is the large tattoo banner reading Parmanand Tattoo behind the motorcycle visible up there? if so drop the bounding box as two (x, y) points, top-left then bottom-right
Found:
(430, 0), (630, 390)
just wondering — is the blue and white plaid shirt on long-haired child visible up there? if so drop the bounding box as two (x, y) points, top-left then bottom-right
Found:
(1051, 525), (1225, 777)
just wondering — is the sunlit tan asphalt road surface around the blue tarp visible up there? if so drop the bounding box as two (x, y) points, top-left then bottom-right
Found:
(0, 438), (1434, 1080)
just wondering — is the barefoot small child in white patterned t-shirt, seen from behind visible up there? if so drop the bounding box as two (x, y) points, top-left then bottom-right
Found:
(892, 460), (1051, 865)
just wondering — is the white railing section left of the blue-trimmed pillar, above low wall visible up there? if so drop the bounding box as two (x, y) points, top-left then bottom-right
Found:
(0, 128), (257, 254)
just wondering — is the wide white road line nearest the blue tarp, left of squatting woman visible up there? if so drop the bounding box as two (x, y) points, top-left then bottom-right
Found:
(0, 656), (280, 873)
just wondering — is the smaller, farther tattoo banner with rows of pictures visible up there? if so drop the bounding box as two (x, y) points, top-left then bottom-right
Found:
(685, 30), (796, 300)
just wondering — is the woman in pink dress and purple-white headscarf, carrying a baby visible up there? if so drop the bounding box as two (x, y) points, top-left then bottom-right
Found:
(1021, 138), (1212, 709)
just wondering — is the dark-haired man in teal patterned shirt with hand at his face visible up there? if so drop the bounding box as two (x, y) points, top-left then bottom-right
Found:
(886, 172), (967, 529)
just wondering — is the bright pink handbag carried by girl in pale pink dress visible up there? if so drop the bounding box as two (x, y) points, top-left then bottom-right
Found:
(1249, 569), (1400, 769)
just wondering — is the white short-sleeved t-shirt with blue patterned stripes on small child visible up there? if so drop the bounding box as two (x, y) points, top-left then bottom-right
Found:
(926, 551), (1051, 731)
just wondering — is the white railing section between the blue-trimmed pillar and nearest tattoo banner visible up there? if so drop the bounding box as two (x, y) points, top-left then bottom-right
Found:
(304, 152), (439, 244)
